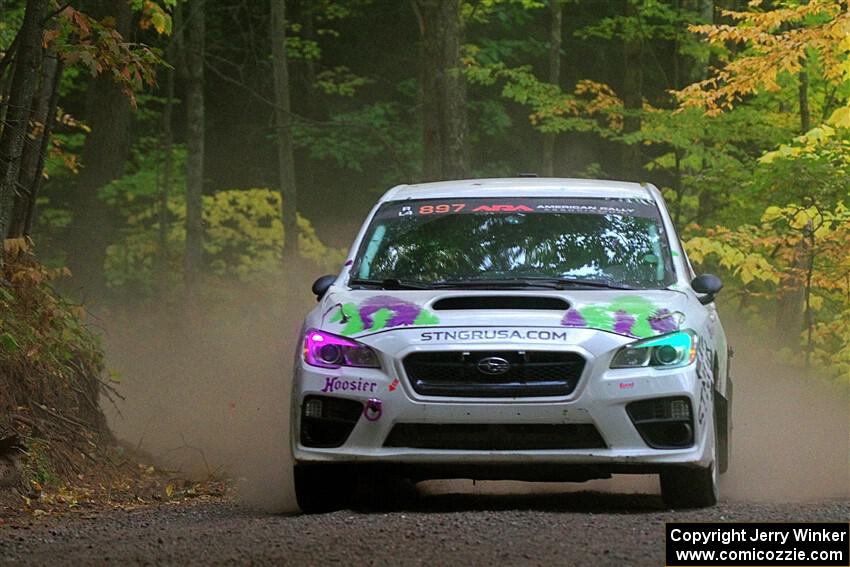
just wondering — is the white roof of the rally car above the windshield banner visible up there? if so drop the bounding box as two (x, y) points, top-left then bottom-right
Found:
(380, 177), (655, 203)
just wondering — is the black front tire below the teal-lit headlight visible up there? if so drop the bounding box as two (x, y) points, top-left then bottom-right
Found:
(660, 420), (720, 508)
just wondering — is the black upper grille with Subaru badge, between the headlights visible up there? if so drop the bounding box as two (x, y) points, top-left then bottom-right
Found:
(404, 350), (585, 398)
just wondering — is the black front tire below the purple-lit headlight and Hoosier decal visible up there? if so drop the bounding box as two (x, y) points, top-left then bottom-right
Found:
(293, 465), (354, 514)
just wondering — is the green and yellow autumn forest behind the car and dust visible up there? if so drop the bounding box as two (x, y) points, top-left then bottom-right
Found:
(0, 0), (850, 398)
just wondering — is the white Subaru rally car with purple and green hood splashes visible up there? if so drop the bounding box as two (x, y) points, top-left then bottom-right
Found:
(291, 178), (732, 512)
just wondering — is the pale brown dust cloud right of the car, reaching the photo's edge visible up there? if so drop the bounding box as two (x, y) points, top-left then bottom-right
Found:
(721, 320), (850, 502)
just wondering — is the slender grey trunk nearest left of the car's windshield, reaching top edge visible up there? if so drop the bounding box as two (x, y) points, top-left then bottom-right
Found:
(271, 0), (298, 263)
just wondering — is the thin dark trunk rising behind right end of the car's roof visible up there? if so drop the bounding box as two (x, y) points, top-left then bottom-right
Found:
(623, 0), (643, 181)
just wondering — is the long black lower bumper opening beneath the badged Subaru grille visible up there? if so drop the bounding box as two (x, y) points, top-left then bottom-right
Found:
(384, 423), (606, 451)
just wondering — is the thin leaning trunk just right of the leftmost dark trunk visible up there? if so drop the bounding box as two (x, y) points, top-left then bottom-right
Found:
(9, 49), (64, 238)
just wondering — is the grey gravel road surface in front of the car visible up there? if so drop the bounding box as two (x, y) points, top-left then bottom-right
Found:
(0, 492), (850, 567)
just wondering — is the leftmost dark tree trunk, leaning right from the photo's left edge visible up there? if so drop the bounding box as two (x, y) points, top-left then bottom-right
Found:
(0, 0), (47, 258)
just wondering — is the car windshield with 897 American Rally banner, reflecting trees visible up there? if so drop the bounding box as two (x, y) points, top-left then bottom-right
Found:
(351, 198), (673, 289)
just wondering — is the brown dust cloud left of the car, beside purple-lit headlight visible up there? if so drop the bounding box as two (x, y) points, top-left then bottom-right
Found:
(104, 278), (315, 512)
